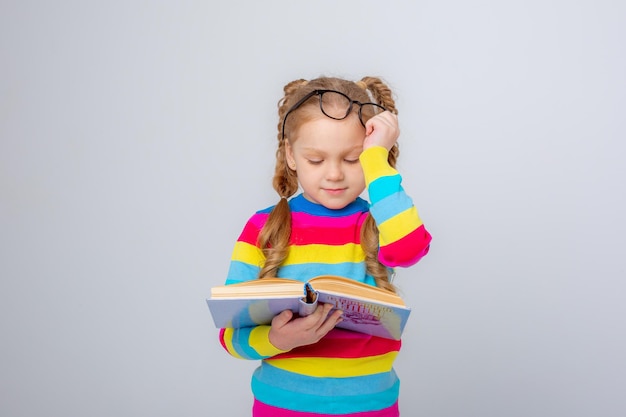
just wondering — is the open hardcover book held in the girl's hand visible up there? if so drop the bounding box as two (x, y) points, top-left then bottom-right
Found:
(206, 275), (411, 340)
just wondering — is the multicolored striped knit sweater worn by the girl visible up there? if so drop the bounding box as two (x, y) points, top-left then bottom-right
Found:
(220, 147), (431, 417)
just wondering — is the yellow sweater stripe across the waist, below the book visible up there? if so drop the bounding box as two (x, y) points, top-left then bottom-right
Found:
(266, 352), (398, 378)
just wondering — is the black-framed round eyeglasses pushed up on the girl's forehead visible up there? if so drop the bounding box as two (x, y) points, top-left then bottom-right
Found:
(283, 90), (387, 140)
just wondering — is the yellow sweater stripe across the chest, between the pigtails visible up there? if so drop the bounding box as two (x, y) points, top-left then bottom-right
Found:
(285, 243), (365, 265)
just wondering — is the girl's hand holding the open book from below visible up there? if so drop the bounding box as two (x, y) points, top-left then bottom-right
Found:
(269, 304), (343, 351)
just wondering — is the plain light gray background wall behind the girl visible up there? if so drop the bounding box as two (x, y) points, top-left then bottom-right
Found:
(0, 0), (626, 417)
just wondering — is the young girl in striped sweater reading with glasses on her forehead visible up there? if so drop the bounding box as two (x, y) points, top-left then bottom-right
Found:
(220, 77), (431, 417)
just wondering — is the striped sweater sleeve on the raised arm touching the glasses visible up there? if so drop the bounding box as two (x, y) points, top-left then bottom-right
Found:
(360, 146), (432, 267)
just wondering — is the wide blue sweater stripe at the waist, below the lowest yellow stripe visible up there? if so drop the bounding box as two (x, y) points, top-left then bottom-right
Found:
(252, 363), (400, 414)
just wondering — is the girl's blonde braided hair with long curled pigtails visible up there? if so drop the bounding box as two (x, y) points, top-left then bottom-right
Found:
(258, 77), (399, 291)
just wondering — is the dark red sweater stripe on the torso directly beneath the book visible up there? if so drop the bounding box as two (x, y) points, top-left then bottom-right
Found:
(274, 329), (401, 359)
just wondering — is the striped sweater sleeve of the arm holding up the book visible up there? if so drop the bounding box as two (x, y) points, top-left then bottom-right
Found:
(219, 213), (283, 360)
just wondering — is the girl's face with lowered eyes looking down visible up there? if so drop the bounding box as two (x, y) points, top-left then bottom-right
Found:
(286, 115), (365, 209)
